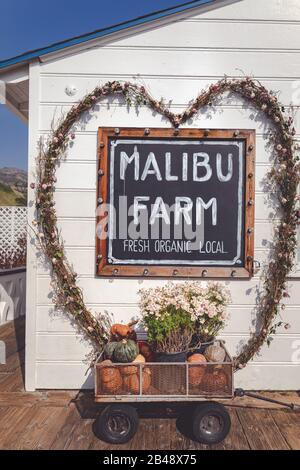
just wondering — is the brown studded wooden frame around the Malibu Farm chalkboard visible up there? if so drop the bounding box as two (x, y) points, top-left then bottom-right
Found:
(96, 127), (255, 278)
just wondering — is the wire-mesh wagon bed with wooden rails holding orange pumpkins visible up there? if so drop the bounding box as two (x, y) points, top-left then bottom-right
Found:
(95, 342), (233, 402)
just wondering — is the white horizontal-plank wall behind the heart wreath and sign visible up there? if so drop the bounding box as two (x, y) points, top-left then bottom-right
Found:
(27, 0), (300, 389)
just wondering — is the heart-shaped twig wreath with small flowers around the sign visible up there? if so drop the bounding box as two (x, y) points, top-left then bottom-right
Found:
(31, 77), (300, 370)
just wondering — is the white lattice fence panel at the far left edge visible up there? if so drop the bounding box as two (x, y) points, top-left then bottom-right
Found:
(0, 206), (27, 251)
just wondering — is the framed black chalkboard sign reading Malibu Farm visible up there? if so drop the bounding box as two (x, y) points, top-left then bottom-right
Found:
(96, 128), (255, 278)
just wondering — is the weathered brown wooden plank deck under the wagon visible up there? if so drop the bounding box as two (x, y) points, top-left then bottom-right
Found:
(0, 319), (300, 450)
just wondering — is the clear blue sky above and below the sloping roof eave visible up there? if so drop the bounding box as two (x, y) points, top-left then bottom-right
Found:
(0, 0), (187, 169)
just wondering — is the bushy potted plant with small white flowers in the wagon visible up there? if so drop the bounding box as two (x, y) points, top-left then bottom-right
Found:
(139, 281), (231, 352)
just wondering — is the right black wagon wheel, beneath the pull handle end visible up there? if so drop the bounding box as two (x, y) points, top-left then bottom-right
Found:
(193, 402), (231, 444)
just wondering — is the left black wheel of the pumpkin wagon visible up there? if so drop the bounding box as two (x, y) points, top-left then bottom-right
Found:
(94, 405), (139, 444)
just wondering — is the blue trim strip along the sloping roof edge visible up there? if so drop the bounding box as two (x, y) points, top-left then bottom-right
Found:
(0, 0), (219, 69)
